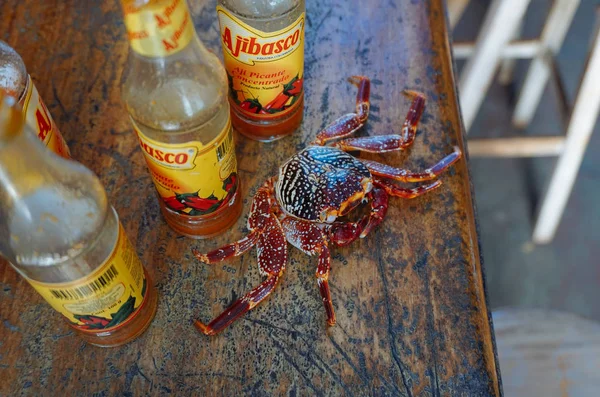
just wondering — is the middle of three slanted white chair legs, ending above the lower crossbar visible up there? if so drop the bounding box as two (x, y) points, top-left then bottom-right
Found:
(513, 0), (580, 128)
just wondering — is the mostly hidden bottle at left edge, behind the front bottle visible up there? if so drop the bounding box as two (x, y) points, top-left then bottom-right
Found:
(0, 40), (71, 158)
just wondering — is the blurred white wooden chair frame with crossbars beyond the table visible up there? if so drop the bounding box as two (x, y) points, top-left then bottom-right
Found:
(447, 0), (600, 244)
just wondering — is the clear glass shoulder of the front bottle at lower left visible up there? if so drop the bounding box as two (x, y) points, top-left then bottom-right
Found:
(0, 132), (108, 266)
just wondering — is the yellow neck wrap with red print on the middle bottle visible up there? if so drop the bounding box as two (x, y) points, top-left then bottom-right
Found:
(125, 0), (194, 57)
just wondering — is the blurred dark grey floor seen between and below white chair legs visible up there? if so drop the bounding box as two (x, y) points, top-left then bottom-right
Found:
(453, 0), (600, 321)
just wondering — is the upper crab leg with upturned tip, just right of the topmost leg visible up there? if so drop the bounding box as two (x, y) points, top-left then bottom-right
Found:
(334, 90), (425, 153)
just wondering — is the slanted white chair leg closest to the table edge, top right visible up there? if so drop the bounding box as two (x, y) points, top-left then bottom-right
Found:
(458, 0), (531, 131)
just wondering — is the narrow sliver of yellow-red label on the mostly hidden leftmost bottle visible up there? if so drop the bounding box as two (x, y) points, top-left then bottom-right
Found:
(21, 76), (71, 159)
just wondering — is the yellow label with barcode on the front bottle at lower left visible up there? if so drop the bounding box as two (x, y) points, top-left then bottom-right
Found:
(26, 225), (146, 332)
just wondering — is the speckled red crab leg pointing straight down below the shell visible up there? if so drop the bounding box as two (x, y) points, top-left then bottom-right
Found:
(281, 217), (335, 325)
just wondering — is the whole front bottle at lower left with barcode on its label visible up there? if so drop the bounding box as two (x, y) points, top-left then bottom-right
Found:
(0, 92), (157, 347)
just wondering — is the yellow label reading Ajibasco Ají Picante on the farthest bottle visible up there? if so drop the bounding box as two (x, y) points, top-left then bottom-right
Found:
(217, 6), (304, 119)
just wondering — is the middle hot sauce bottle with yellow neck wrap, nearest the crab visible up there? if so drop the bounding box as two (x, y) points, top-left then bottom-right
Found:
(122, 0), (242, 238)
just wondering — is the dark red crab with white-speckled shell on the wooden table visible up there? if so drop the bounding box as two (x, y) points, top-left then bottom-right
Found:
(192, 76), (461, 335)
